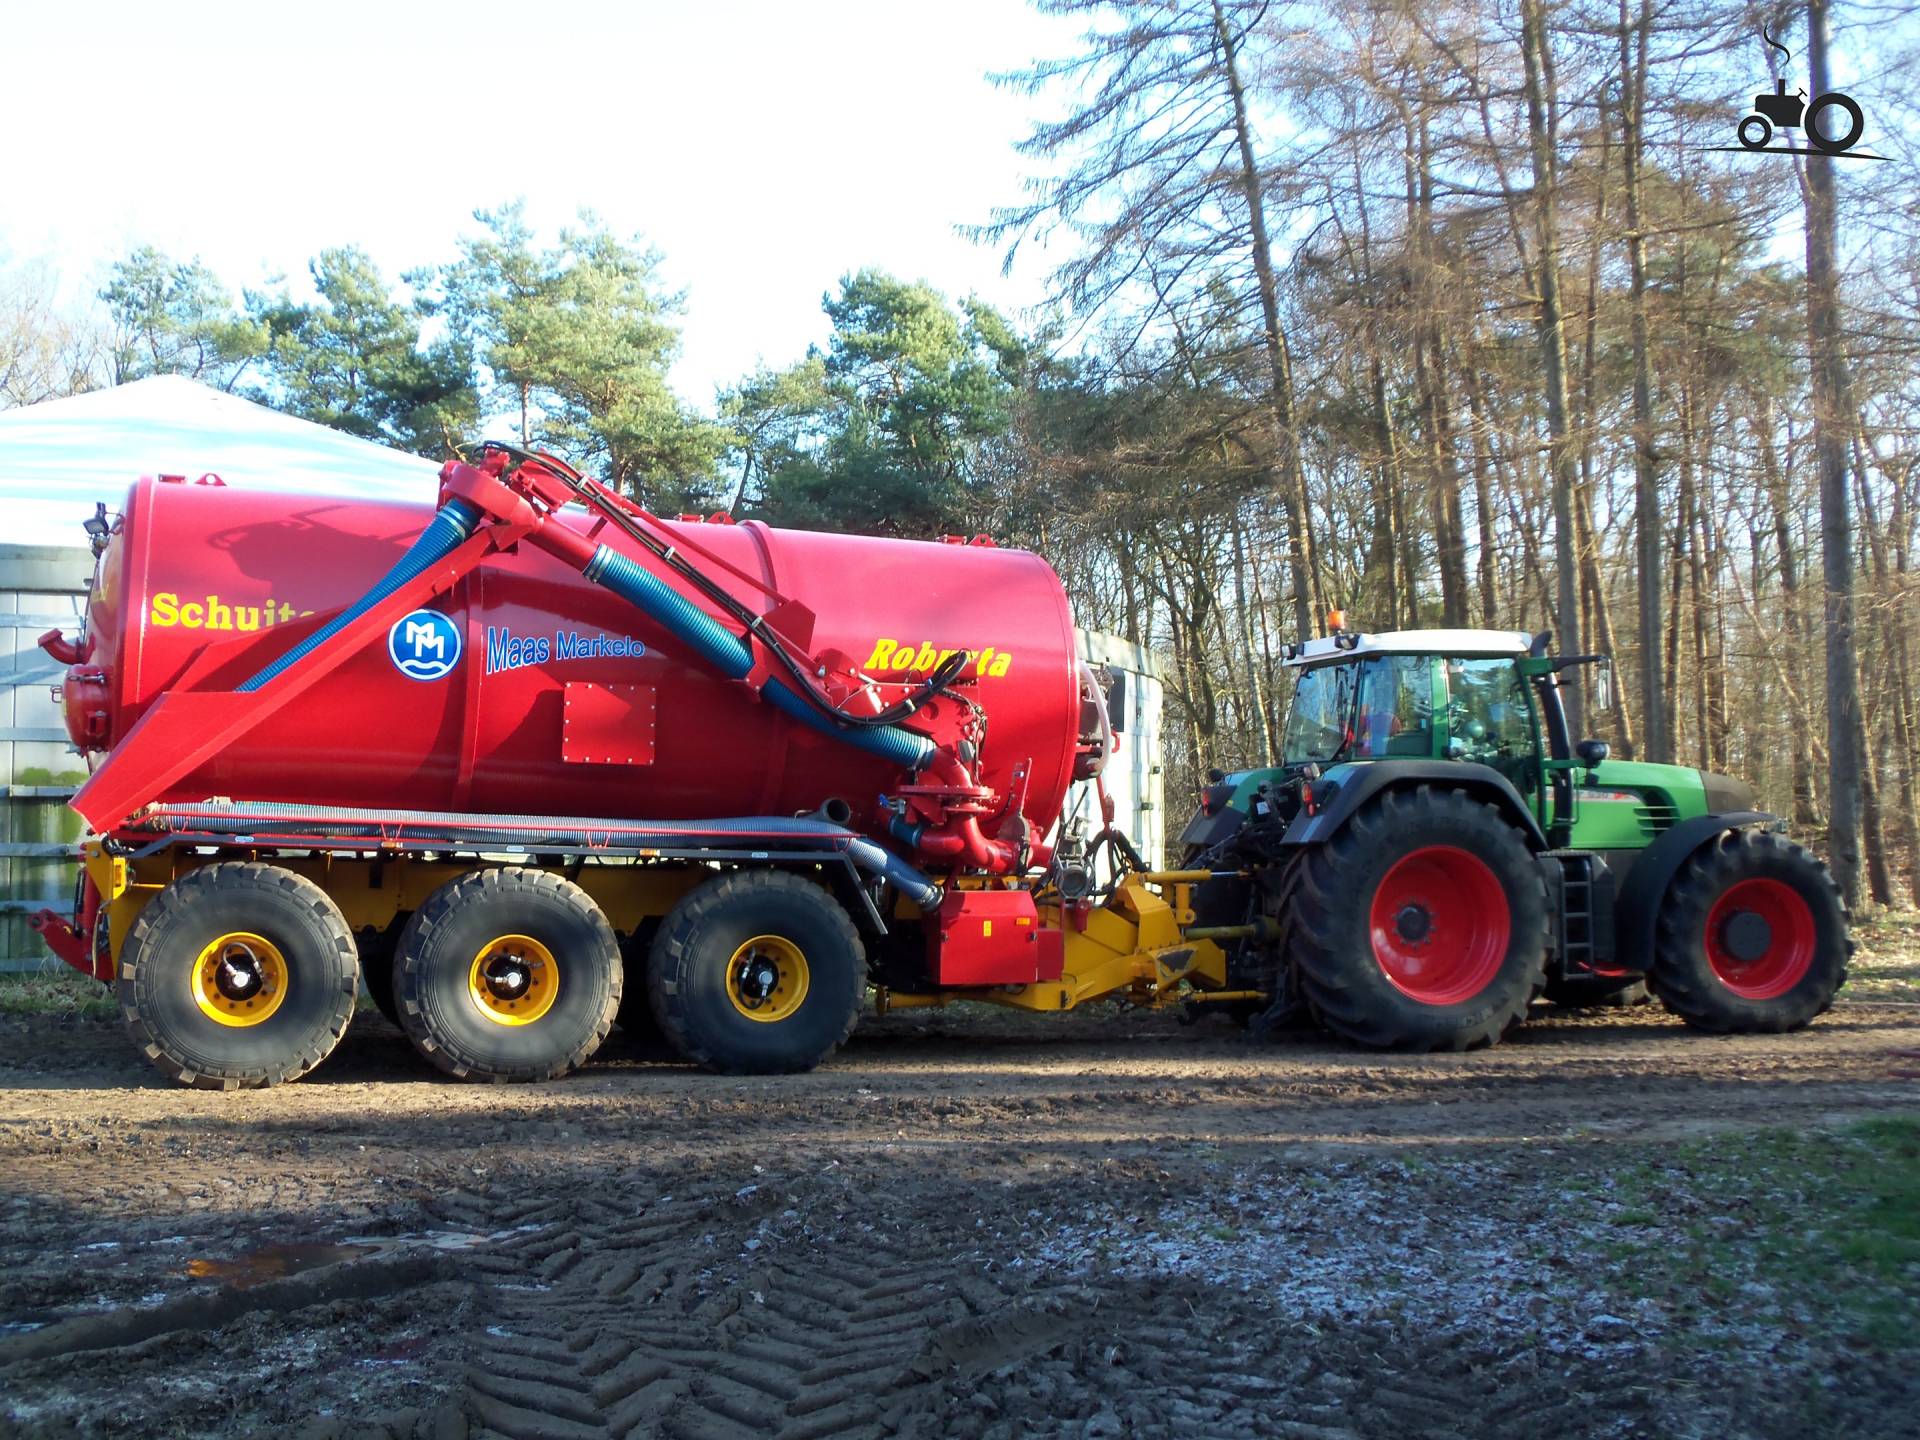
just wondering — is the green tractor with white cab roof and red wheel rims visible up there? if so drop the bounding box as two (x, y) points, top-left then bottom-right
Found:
(1181, 630), (1851, 1050)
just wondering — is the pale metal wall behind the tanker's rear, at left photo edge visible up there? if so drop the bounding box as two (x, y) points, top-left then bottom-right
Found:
(0, 545), (94, 972)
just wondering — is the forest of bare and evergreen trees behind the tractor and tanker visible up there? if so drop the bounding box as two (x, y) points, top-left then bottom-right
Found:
(0, 0), (1920, 904)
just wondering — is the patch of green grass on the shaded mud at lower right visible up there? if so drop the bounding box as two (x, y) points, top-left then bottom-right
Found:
(1601, 1116), (1920, 1352)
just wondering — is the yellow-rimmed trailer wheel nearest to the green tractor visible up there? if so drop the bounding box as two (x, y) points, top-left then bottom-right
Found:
(647, 870), (866, 1075)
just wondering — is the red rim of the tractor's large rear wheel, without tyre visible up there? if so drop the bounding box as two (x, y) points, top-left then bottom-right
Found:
(1367, 845), (1513, 1004)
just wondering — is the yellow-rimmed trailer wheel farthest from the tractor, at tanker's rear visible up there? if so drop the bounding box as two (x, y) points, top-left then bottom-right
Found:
(115, 860), (359, 1091)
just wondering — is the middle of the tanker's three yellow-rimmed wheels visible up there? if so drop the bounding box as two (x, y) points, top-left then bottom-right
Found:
(394, 868), (620, 1081)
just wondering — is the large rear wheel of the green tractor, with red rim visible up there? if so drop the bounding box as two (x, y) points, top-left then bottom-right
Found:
(1283, 785), (1548, 1050)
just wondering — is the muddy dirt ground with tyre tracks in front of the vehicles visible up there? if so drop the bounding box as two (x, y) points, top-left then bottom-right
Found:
(0, 940), (1920, 1440)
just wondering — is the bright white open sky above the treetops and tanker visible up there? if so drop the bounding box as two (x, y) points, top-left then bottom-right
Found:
(0, 0), (1079, 405)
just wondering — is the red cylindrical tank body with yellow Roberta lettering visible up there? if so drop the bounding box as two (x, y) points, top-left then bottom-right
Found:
(65, 478), (1081, 852)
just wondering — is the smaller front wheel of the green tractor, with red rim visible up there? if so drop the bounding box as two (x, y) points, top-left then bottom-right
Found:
(1647, 829), (1853, 1035)
